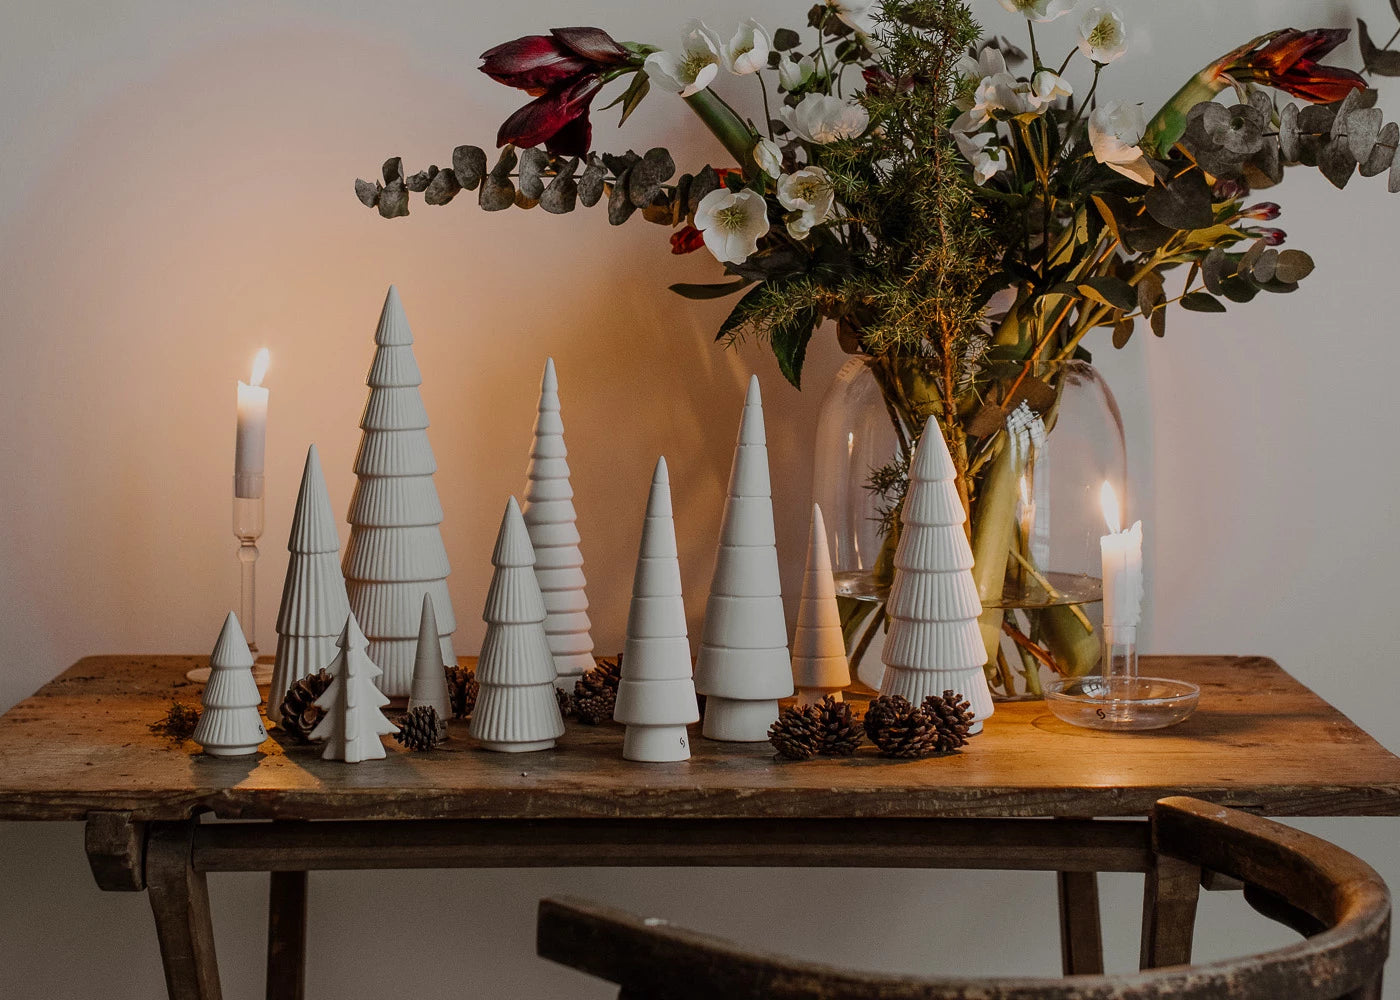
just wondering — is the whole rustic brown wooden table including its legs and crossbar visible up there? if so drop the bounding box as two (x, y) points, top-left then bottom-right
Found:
(0, 657), (1400, 1000)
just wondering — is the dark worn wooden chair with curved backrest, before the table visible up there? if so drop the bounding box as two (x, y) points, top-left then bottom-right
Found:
(536, 798), (1390, 1000)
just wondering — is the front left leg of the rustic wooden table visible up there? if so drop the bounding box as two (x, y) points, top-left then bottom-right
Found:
(146, 822), (221, 1000)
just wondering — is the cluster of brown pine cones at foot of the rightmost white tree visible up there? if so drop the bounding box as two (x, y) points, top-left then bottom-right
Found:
(769, 690), (973, 761)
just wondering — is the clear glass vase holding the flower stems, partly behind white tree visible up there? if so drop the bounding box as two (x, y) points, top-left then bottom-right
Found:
(813, 356), (1127, 699)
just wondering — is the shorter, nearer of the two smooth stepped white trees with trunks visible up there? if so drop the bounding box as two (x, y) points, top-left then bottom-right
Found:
(613, 458), (700, 762)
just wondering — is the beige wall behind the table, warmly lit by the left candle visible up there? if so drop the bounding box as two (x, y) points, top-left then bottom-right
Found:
(0, 0), (1400, 999)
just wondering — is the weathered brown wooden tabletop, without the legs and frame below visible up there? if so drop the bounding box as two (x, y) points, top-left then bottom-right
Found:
(0, 655), (1400, 821)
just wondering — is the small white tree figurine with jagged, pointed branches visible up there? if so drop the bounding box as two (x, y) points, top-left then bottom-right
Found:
(311, 615), (399, 763)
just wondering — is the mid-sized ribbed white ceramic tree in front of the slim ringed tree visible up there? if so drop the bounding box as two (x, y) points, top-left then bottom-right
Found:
(470, 497), (564, 754)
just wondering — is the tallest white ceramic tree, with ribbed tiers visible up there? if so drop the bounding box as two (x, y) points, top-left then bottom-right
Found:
(344, 286), (456, 697)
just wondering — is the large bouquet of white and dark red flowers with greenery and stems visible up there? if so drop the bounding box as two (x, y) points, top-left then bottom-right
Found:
(356, 0), (1400, 696)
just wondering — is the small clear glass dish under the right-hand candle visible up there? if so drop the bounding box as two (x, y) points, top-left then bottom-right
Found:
(1044, 676), (1201, 732)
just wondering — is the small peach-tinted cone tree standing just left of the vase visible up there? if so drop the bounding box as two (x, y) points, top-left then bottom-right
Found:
(792, 504), (851, 704)
